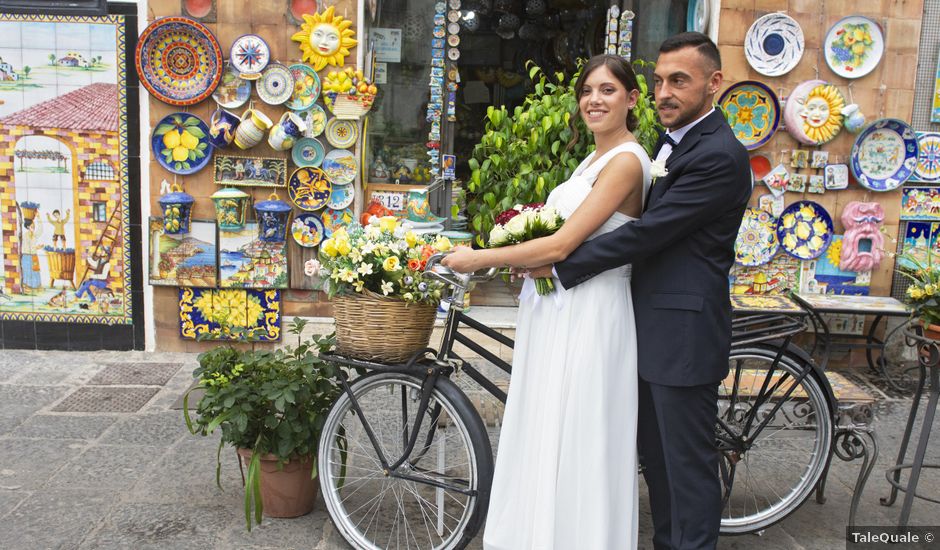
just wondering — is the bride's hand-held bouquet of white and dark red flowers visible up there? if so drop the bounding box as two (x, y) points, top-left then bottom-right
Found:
(489, 202), (565, 296)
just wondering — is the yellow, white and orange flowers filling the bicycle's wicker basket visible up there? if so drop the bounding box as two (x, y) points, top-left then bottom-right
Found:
(316, 216), (451, 304)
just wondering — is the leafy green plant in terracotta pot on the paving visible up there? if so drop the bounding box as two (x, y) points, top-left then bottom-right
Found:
(183, 319), (342, 531)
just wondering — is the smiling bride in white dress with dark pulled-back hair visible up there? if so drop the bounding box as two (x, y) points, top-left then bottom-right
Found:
(443, 55), (650, 550)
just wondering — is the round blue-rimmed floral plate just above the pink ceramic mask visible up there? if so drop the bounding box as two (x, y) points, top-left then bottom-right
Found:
(849, 118), (917, 191)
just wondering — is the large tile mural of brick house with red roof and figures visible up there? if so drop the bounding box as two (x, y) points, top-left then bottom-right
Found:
(0, 14), (131, 324)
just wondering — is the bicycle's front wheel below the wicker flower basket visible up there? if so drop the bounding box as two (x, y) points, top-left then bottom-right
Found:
(319, 373), (493, 549)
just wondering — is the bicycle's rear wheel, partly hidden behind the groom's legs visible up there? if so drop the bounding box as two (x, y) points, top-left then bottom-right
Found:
(718, 345), (833, 534)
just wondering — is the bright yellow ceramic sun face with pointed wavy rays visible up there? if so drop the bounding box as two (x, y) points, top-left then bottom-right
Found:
(290, 6), (358, 71)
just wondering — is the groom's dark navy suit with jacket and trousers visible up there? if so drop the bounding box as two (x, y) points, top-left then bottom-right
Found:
(555, 110), (751, 550)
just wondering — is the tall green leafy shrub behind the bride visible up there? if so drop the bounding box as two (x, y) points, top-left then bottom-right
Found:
(467, 60), (661, 245)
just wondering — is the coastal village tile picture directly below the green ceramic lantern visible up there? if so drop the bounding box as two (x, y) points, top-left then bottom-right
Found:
(219, 222), (288, 288)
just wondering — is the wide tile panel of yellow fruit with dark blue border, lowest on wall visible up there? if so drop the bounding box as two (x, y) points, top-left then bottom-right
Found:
(179, 288), (281, 342)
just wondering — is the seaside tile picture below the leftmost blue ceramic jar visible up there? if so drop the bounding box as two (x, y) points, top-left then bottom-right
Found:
(148, 218), (218, 288)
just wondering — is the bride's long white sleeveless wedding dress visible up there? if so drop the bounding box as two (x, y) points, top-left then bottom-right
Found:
(483, 143), (650, 550)
